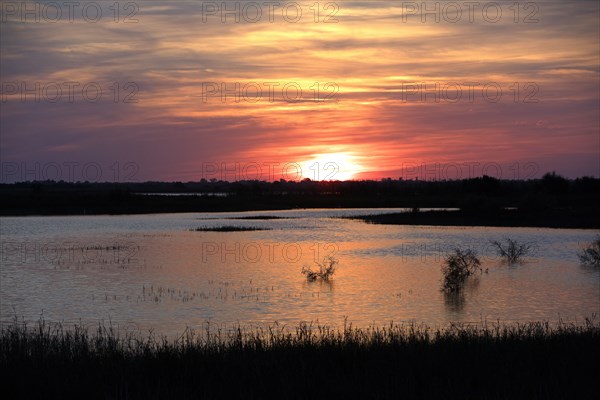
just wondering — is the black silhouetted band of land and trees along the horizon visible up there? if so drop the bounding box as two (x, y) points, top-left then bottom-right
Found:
(0, 173), (600, 217)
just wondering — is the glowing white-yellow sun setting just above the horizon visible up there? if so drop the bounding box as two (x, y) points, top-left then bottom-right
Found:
(300, 152), (363, 181)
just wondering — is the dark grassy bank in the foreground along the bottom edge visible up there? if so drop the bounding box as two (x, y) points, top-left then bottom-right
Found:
(0, 321), (600, 399)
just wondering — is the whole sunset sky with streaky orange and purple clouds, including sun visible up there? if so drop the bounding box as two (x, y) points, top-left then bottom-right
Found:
(0, 0), (600, 182)
